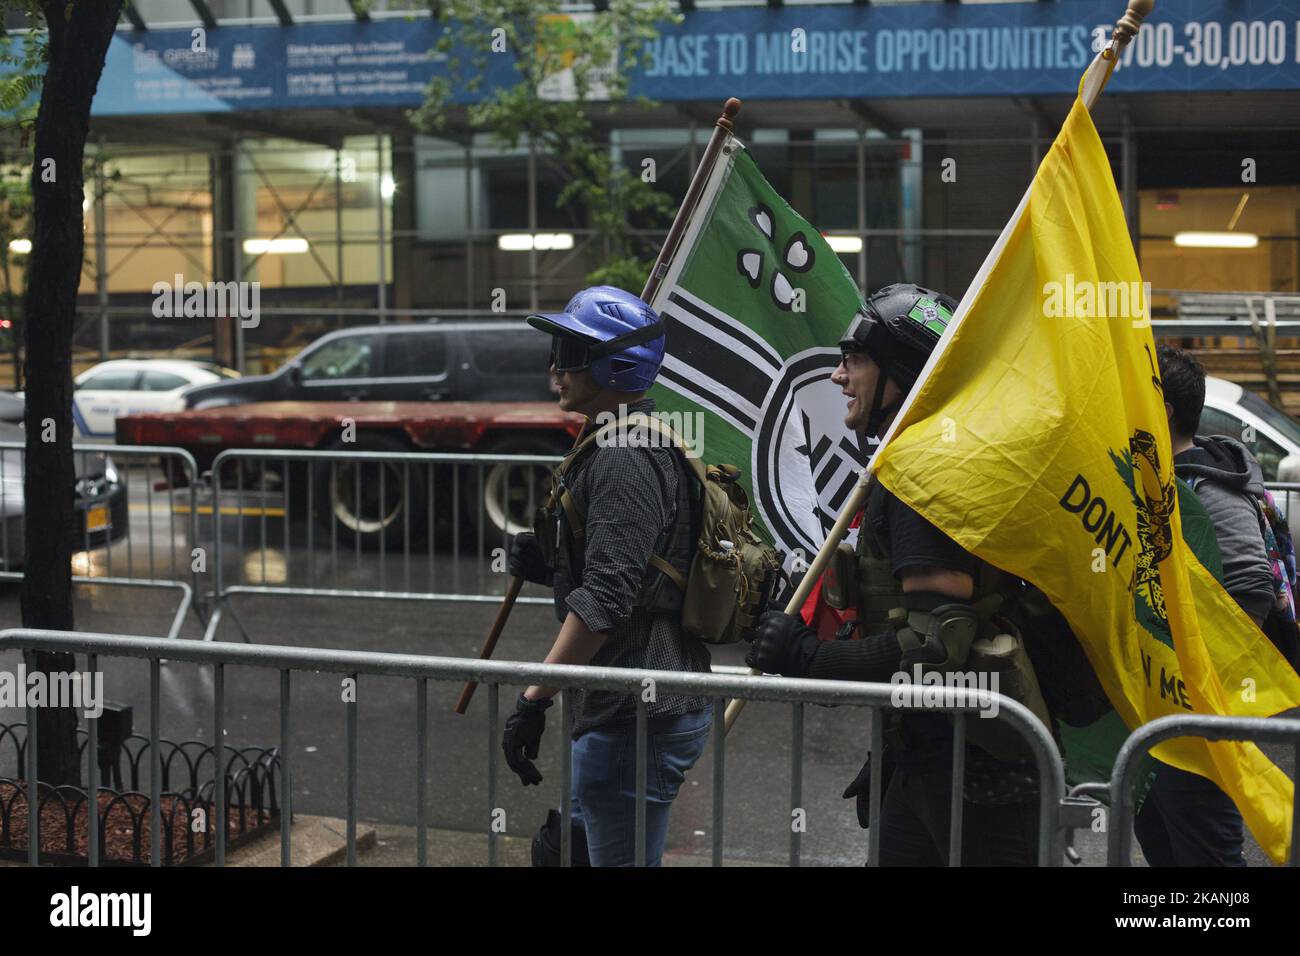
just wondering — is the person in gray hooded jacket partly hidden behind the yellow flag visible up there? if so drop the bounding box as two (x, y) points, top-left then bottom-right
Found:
(1134, 346), (1274, 866)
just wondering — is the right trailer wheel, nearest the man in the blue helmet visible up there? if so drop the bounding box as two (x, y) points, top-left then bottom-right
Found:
(462, 434), (572, 540)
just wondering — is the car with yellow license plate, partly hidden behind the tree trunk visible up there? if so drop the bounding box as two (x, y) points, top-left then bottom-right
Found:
(0, 423), (127, 571)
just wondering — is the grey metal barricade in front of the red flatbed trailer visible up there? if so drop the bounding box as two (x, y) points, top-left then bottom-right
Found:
(205, 449), (560, 640)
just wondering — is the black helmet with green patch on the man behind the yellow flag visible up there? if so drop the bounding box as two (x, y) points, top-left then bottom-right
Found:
(840, 282), (957, 436)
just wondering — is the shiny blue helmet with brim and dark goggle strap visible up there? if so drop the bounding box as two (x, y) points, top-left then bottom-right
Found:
(528, 285), (666, 392)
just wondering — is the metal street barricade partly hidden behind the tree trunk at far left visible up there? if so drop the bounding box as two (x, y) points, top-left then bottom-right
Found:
(0, 441), (203, 637)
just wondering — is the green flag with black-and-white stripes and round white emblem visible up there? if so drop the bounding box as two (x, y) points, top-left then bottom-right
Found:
(650, 137), (868, 561)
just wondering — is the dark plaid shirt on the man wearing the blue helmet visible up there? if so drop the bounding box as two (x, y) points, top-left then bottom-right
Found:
(555, 398), (710, 739)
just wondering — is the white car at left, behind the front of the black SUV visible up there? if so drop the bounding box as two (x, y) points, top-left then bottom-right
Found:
(73, 359), (239, 441)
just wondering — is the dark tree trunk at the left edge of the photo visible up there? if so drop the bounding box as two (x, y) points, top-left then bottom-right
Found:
(22, 0), (122, 786)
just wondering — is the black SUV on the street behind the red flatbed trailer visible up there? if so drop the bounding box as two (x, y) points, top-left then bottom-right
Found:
(185, 320), (554, 408)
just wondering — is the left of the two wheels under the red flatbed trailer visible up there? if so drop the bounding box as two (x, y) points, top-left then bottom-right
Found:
(312, 434), (426, 550)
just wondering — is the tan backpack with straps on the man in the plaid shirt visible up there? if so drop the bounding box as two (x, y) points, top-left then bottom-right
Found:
(554, 412), (785, 644)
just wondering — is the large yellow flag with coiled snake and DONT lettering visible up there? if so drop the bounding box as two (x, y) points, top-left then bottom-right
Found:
(872, 57), (1300, 861)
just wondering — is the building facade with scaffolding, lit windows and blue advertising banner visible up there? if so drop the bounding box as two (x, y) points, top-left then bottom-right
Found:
(5, 0), (1300, 369)
